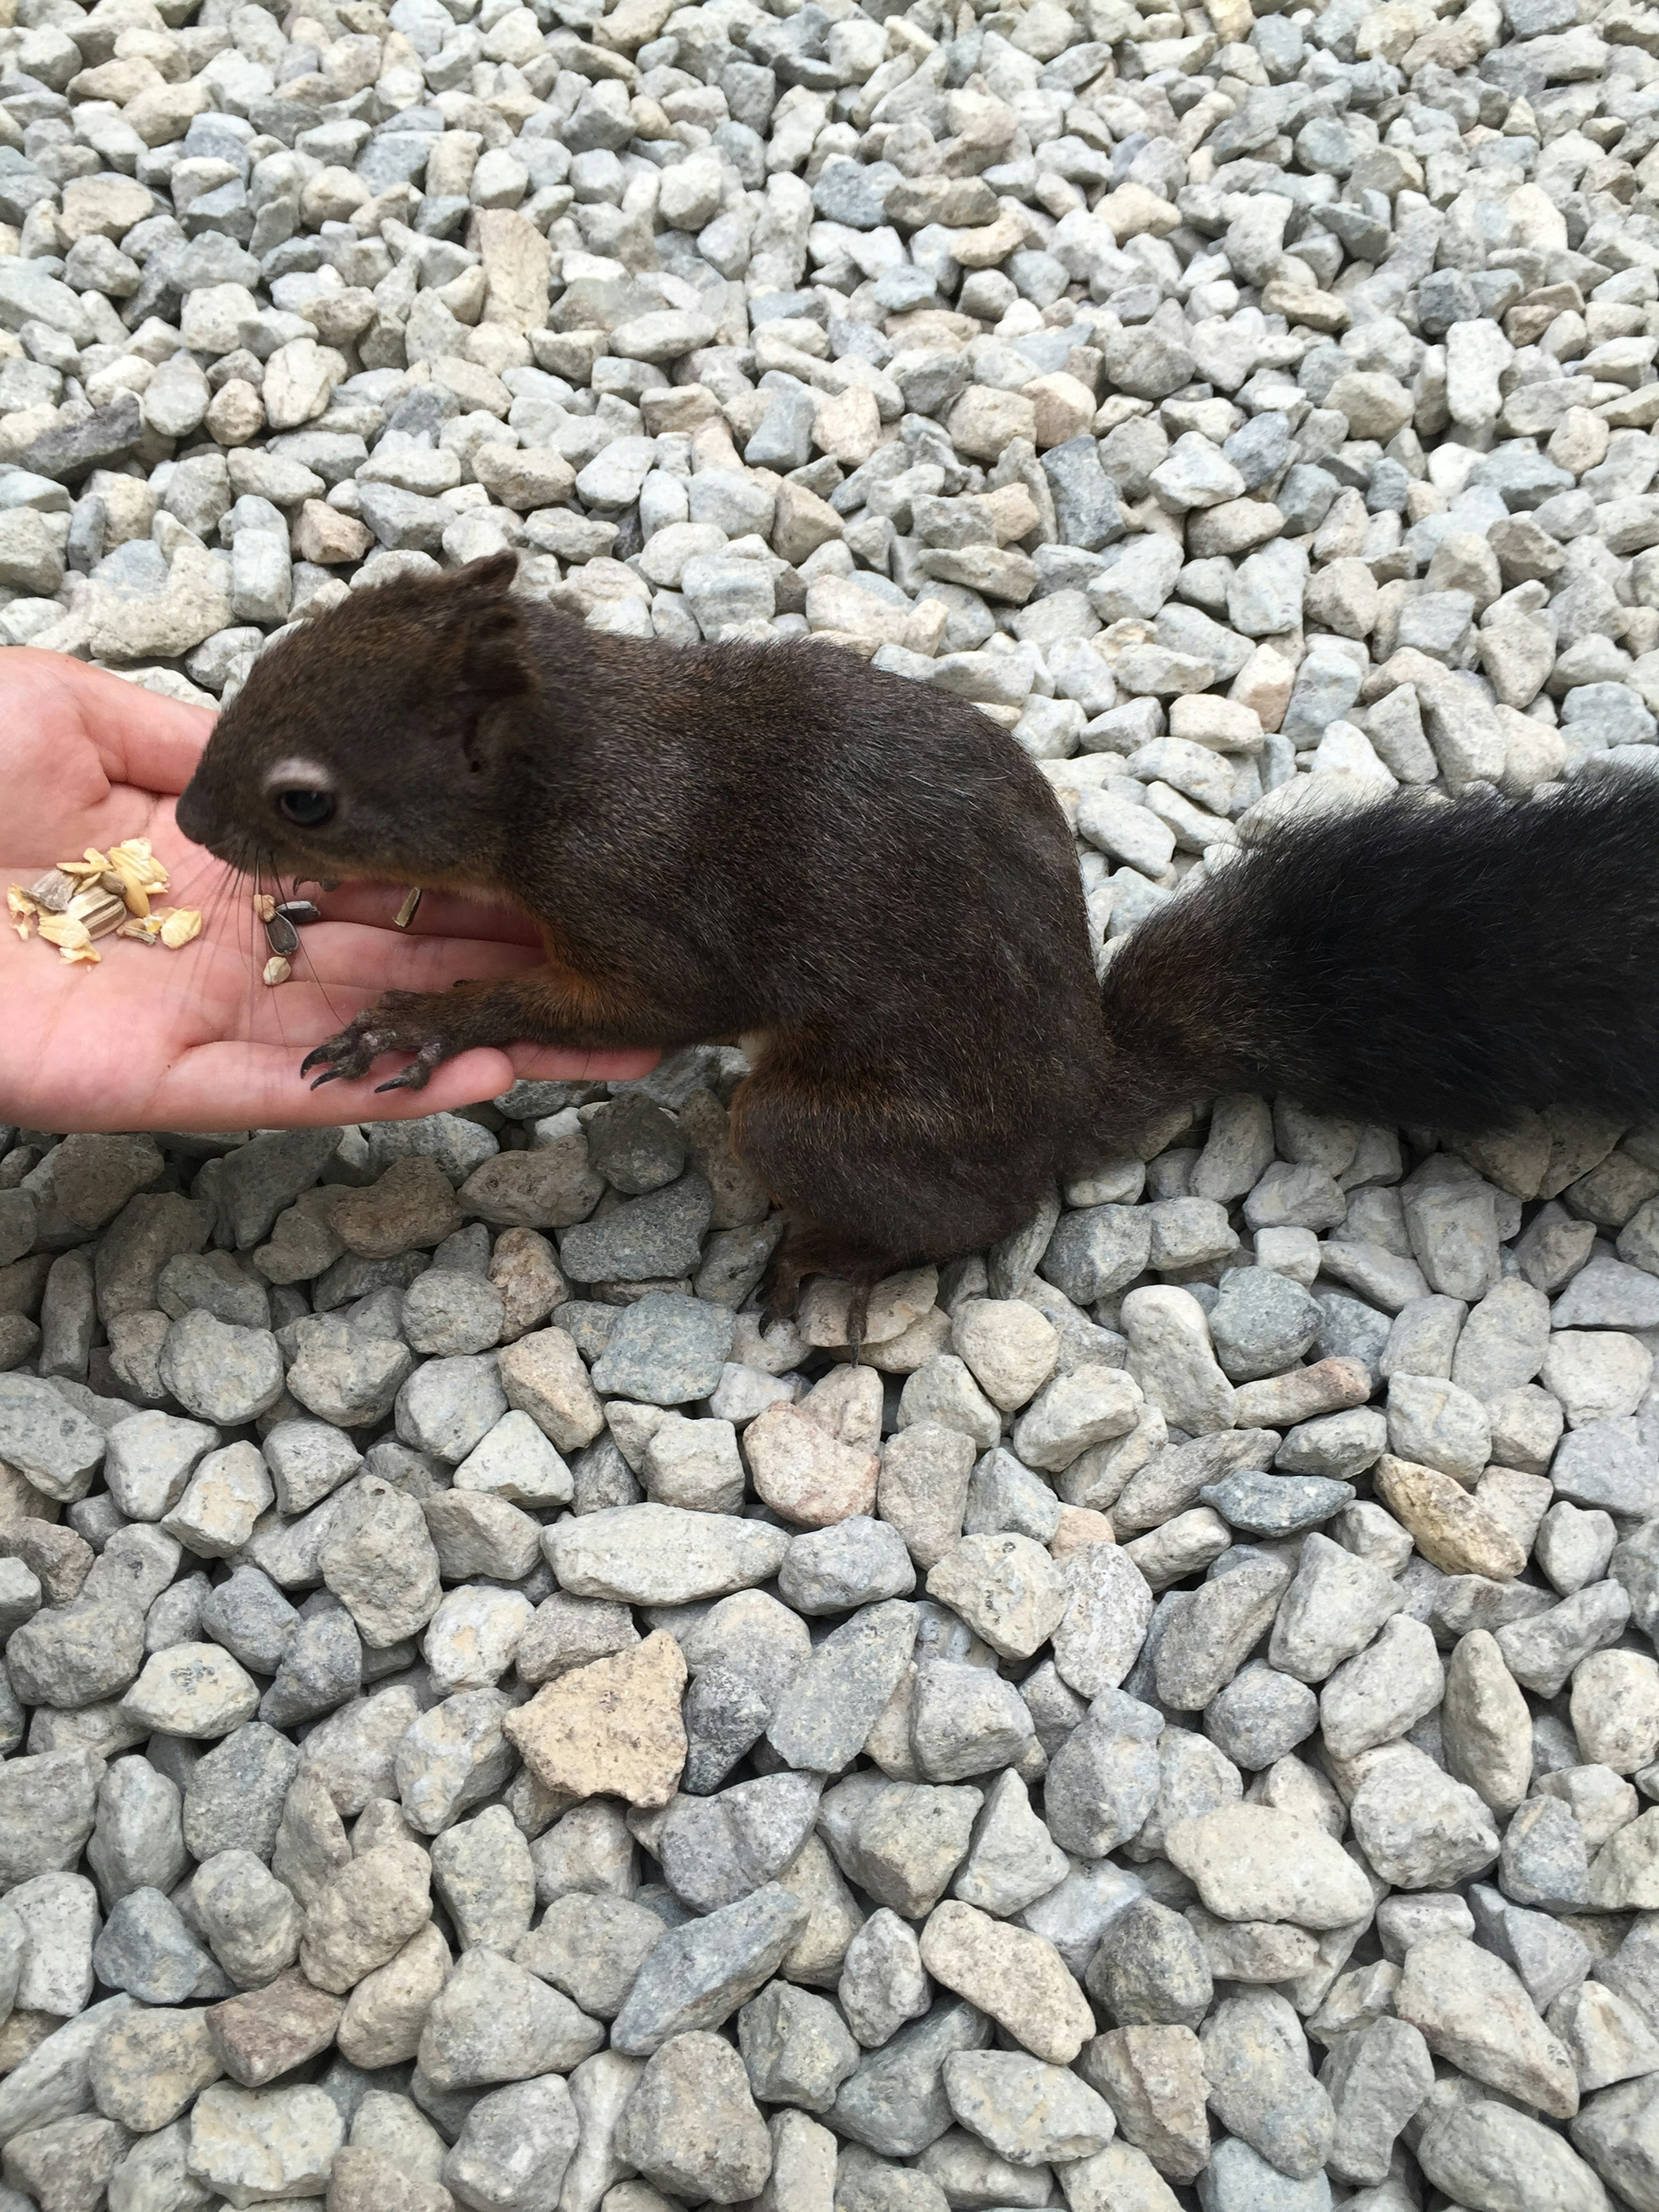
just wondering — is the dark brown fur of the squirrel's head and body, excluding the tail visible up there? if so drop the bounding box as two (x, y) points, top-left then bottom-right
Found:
(179, 557), (1108, 1281)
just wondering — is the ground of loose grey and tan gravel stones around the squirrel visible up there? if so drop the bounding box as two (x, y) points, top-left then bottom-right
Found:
(0, 0), (1659, 2212)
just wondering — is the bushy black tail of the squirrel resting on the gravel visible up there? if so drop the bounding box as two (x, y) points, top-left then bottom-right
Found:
(1104, 772), (1659, 1135)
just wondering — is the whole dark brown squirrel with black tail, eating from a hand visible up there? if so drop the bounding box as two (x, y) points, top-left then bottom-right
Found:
(177, 553), (1659, 1312)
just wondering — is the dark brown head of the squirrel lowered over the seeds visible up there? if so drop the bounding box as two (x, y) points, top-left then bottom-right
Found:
(177, 553), (537, 883)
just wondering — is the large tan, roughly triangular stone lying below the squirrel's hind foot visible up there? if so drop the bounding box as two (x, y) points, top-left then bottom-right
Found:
(502, 1628), (686, 1805)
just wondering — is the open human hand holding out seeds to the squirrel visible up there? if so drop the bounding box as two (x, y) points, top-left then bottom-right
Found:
(0, 646), (657, 1132)
